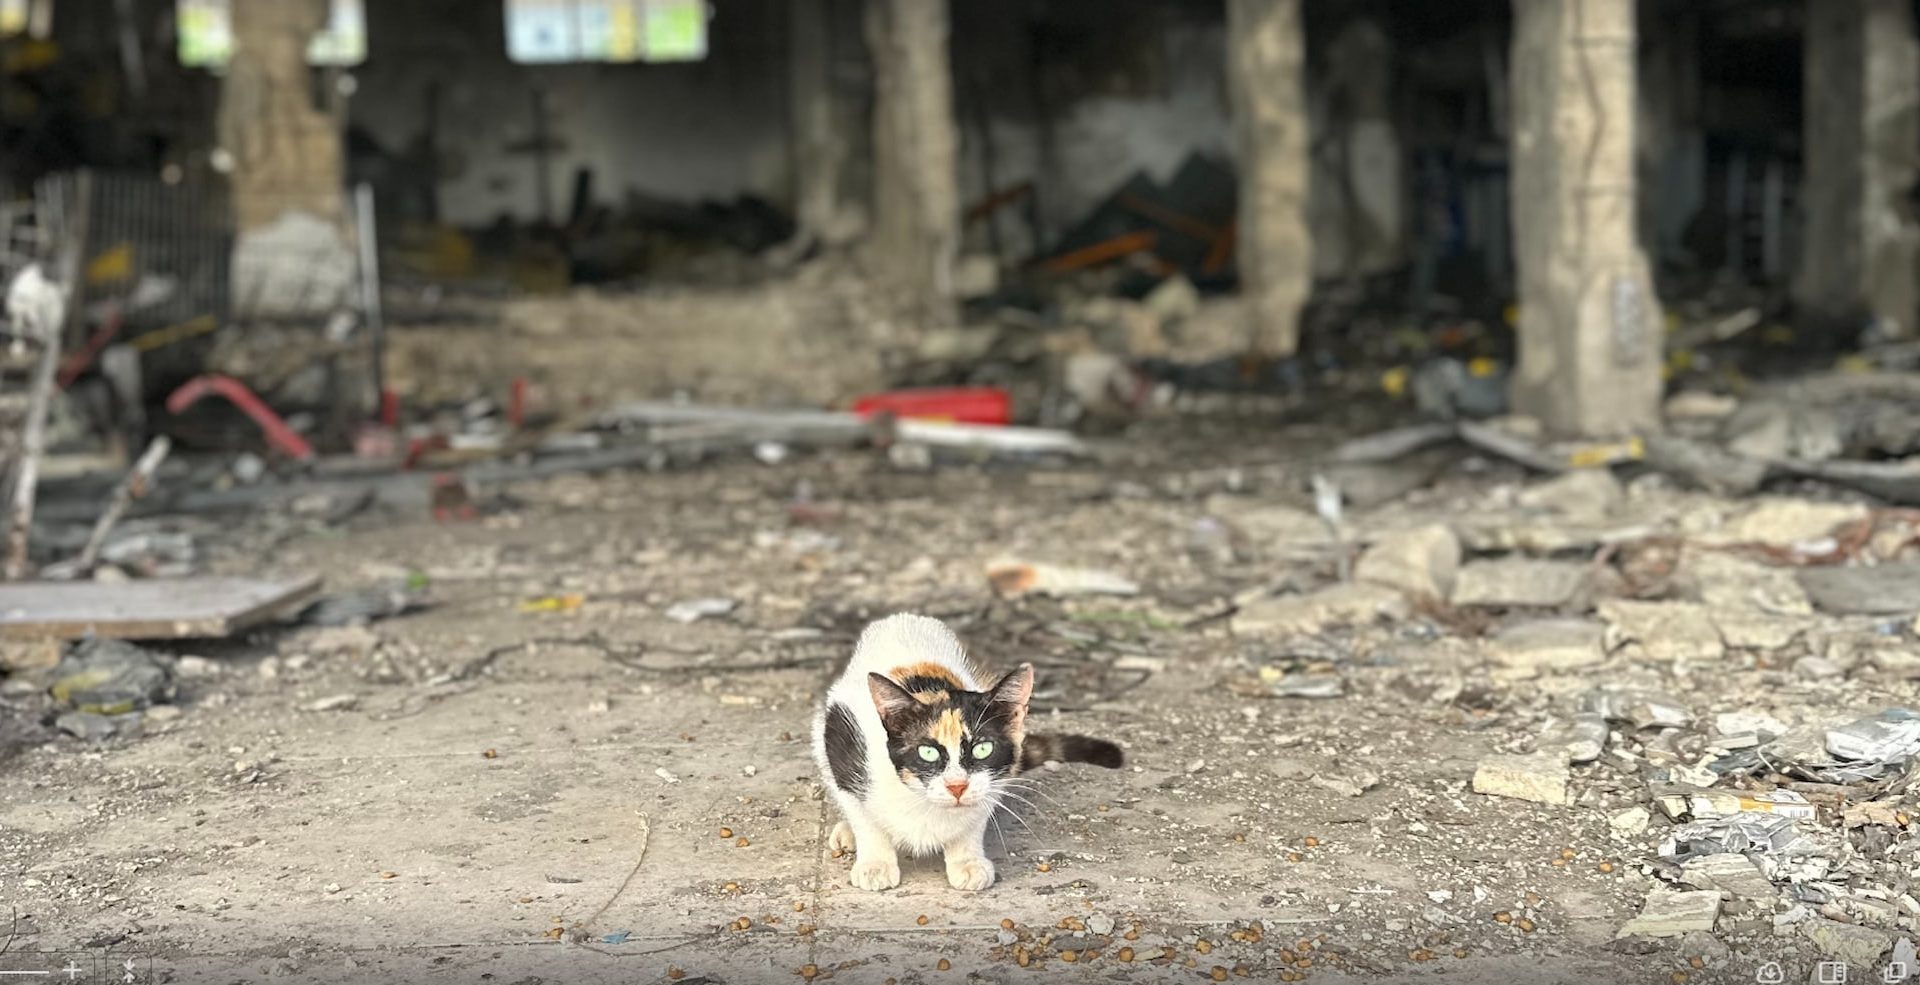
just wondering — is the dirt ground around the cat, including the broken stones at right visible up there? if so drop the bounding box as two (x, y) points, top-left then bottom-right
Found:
(0, 422), (1920, 985)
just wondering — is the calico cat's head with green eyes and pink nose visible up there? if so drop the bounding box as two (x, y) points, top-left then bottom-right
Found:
(866, 664), (1033, 808)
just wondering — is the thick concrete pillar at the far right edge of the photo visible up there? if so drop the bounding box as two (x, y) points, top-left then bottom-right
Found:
(1793, 0), (1920, 336)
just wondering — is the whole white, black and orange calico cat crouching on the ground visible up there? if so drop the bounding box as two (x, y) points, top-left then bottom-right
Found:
(814, 614), (1123, 889)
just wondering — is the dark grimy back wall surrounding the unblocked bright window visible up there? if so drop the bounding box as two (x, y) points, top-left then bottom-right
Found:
(351, 0), (791, 225)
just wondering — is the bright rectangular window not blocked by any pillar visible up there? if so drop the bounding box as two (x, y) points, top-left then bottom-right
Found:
(507, 0), (707, 63)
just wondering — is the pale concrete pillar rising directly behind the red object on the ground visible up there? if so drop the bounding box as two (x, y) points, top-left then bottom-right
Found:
(866, 0), (960, 324)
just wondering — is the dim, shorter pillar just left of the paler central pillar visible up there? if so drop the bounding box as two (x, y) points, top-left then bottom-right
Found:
(787, 0), (864, 246)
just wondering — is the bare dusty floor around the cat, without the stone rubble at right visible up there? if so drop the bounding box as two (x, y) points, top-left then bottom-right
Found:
(0, 439), (1914, 985)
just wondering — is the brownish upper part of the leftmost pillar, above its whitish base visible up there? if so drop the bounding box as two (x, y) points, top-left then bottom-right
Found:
(219, 0), (346, 232)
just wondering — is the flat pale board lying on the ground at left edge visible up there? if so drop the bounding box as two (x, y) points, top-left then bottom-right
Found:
(0, 574), (321, 639)
